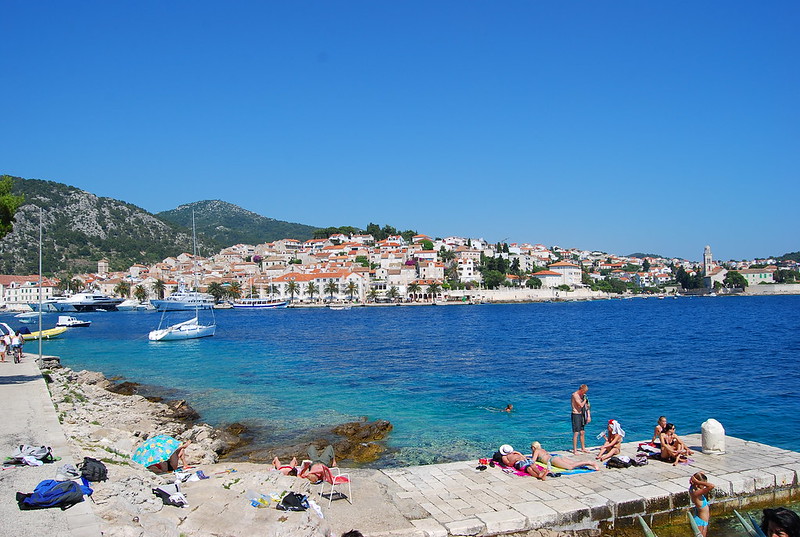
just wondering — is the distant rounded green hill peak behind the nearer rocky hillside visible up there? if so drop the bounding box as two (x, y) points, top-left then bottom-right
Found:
(156, 200), (317, 246)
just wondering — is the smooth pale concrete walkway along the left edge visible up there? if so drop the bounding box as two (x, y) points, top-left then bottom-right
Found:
(0, 354), (101, 537)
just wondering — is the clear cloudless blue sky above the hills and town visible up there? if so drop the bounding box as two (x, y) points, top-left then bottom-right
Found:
(0, 0), (800, 259)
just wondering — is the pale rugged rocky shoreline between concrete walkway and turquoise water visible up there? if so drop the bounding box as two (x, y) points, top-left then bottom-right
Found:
(42, 363), (404, 537)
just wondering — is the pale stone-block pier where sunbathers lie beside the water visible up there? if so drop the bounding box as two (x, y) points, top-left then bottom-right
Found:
(360, 434), (800, 537)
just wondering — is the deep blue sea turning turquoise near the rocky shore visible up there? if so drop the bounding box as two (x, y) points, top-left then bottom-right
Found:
(7, 296), (800, 466)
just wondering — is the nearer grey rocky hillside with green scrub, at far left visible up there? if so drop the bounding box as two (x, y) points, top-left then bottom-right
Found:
(0, 177), (220, 274)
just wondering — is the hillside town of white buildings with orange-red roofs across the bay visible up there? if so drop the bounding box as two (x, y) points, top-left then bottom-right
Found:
(0, 233), (800, 309)
